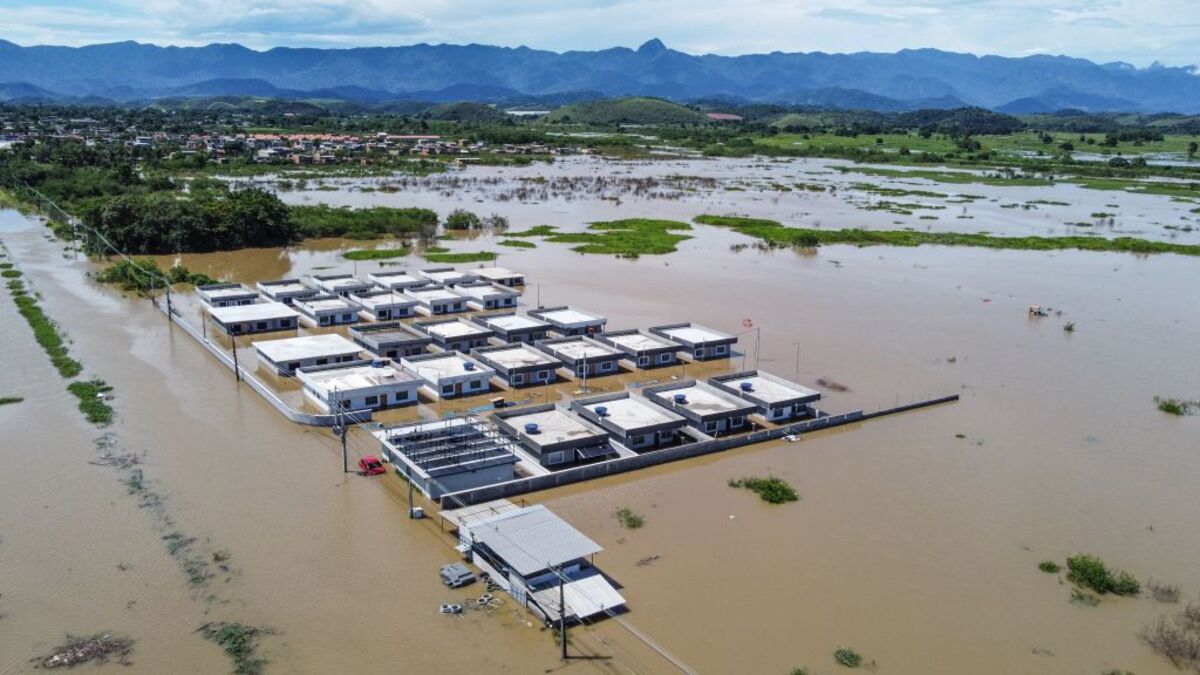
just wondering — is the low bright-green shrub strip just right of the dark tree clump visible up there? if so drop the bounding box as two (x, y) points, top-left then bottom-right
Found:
(292, 204), (438, 239)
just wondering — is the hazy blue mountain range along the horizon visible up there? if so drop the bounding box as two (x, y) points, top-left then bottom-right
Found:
(0, 40), (1200, 114)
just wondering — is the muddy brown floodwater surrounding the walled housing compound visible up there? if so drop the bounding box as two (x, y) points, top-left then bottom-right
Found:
(0, 154), (1200, 675)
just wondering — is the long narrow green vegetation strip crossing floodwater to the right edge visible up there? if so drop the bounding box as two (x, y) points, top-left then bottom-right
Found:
(694, 215), (1200, 256)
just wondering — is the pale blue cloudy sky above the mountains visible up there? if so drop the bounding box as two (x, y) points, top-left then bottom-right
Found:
(0, 0), (1200, 66)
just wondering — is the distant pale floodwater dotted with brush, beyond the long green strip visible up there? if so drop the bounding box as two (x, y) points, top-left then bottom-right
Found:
(243, 156), (1200, 244)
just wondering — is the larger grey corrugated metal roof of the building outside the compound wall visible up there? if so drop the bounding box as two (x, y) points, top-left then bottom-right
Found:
(469, 504), (604, 577)
